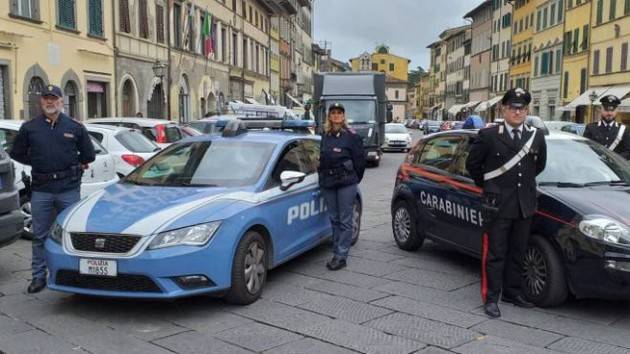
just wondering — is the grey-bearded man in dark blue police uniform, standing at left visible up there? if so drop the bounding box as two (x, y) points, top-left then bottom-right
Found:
(10, 85), (95, 293)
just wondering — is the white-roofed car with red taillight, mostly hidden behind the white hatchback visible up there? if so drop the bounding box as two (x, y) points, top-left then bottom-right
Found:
(85, 117), (186, 148)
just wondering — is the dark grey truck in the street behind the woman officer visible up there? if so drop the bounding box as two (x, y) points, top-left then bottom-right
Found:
(313, 72), (392, 166)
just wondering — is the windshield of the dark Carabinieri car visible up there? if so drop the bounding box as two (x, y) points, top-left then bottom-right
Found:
(537, 138), (630, 187)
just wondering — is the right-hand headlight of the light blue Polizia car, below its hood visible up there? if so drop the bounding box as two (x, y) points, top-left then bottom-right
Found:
(149, 221), (221, 250)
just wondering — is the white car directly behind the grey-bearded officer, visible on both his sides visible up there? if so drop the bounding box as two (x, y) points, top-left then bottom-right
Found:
(0, 120), (119, 238)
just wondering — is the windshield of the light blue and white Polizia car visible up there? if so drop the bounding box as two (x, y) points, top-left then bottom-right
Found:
(124, 141), (274, 187)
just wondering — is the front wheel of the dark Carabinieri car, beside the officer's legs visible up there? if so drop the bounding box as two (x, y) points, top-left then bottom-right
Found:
(523, 236), (569, 307)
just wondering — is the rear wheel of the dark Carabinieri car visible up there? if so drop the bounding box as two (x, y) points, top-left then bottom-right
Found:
(392, 200), (424, 251)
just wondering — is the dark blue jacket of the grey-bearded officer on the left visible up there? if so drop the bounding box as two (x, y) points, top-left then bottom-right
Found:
(10, 113), (96, 193)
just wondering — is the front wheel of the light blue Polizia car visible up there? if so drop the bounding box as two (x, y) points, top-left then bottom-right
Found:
(225, 231), (267, 305)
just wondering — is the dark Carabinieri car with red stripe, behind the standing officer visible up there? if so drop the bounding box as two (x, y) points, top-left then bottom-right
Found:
(391, 131), (630, 306)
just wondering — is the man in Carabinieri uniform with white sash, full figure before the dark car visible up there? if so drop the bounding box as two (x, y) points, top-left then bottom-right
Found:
(466, 88), (547, 318)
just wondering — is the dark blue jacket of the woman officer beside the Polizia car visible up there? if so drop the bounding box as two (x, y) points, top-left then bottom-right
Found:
(318, 129), (365, 188)
